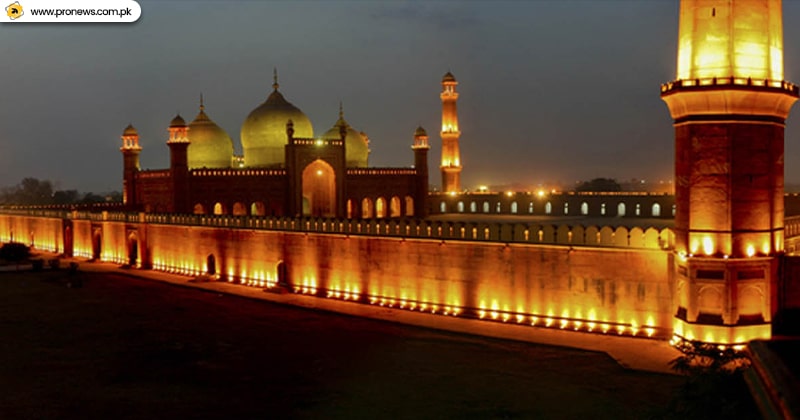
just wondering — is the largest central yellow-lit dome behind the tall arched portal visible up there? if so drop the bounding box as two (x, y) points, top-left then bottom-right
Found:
(242, 80), (314, 167)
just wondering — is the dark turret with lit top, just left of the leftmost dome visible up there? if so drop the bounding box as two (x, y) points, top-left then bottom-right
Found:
(167, 110), (190, 213)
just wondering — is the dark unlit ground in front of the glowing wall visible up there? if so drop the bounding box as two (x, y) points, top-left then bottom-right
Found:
(0, 272), (683, 419)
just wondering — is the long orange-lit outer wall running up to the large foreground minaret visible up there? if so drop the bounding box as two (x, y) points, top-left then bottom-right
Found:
(0, 214), (672, 337)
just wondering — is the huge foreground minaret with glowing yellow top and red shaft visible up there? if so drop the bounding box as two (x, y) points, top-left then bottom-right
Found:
(661, 0), (798, 344)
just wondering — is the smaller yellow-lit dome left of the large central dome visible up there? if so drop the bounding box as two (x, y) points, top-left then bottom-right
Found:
(186, 102), (233, 169)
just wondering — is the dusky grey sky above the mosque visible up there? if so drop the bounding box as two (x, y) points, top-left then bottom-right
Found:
(0, 0), (800, 192)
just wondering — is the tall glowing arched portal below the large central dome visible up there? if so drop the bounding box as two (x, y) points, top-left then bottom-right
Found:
(303, 159), (336, 217)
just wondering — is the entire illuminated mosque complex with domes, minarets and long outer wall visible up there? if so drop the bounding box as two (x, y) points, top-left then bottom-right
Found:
(0, 0), (800, 360)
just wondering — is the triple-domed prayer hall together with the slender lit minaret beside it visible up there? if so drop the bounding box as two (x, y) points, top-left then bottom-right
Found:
(120, 71), (460, 219)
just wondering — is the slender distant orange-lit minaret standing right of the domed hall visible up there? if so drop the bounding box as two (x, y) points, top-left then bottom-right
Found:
(439, 71), (461, 193)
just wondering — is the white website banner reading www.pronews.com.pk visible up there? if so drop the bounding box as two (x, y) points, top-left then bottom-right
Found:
(0, 0), (142, 23)
